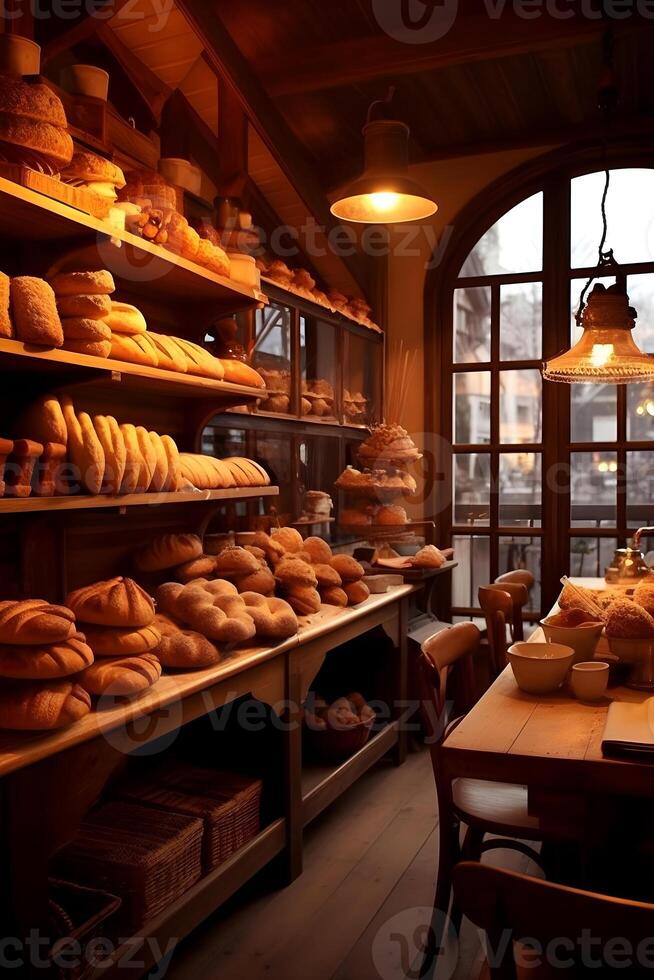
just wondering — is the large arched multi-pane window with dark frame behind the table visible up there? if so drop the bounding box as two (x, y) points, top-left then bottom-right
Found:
(432, 157), (654, 619)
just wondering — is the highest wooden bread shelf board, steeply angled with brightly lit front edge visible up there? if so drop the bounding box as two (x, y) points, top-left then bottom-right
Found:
(0, 177), (266, 313)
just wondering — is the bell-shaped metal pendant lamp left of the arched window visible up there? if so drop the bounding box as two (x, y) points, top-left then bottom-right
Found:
(332, 119), (438, 225)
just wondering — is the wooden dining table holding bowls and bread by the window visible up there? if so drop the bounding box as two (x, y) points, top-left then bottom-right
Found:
(441, 579), (654, 837)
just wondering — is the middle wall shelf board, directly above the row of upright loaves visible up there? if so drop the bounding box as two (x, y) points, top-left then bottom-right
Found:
(0, 339), (266, 408)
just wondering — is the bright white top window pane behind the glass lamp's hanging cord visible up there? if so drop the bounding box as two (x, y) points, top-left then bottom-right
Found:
(572, 169), (654, 269)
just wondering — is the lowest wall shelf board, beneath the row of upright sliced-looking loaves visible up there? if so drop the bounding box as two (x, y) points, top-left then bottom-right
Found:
(0, 487), (279, 515)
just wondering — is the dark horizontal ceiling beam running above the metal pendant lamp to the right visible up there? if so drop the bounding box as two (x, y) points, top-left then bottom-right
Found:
(252, 13), (620, 98)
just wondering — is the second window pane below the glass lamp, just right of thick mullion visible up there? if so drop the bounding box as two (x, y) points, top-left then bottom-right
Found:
(570, 452), (618, 527)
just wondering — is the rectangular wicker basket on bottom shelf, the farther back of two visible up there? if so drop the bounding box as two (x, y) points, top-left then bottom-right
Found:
(120, 765), (262, 871)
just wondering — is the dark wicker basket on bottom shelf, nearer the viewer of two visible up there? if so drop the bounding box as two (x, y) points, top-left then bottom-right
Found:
(58, 803), (203, 929)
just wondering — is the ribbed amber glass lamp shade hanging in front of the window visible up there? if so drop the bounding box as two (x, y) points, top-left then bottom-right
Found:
(543, 283), (654, 384)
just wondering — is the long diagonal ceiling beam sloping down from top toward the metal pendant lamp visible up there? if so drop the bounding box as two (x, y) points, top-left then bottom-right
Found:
(177, 0), (369, 292)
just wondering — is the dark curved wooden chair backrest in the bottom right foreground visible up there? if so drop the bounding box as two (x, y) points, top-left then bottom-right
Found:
(454, 862), (654, 980)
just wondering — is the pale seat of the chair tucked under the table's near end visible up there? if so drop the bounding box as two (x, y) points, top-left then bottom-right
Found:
(452, 779), (543, 840)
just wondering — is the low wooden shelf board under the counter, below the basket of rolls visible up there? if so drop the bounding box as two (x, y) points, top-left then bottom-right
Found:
(302, 722), (398, 826)
